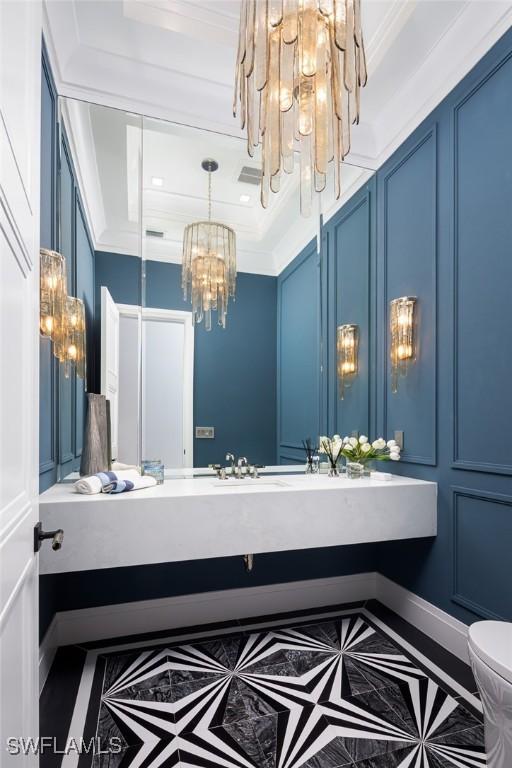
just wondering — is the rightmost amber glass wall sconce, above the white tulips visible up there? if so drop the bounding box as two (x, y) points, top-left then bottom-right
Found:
(389, 296), (417, 393)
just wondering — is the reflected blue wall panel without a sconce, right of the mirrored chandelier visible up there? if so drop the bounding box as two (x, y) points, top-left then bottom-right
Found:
(277, 241), (321, 463)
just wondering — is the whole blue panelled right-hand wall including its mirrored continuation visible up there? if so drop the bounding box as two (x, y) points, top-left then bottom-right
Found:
(278, 25), (512, 623)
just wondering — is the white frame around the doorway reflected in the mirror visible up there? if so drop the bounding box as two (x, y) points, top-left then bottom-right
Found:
(117, 304), (194, 467)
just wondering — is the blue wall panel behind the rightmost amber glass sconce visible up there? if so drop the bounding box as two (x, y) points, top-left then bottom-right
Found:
(379, 123), (437, 465)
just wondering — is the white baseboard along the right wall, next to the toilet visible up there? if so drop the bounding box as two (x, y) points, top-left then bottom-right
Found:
(375, 573), (469, 664)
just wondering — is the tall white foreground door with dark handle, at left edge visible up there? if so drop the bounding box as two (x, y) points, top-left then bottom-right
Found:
(0, 0), (41, 768)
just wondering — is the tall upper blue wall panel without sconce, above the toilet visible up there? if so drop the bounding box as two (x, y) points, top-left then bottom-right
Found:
(454, 48), (512, 474)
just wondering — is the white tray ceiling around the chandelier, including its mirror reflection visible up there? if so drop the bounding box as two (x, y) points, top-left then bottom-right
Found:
(45, 0), (512, 274)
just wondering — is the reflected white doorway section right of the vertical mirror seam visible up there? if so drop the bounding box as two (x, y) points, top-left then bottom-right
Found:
(142, 309), (194, 468)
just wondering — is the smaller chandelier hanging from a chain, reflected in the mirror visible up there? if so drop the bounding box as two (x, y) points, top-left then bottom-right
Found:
(181, 159), (236, 331)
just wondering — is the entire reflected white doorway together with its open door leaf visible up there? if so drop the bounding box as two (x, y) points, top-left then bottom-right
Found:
(101, 286), (194, 468)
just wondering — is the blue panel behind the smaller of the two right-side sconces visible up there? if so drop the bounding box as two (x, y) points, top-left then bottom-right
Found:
(327, 182), (375, 435)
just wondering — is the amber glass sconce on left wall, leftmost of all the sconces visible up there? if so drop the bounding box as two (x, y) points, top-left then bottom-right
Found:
(39, 248), (67, 341)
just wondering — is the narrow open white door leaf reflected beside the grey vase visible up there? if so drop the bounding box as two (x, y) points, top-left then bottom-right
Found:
(101, 285), (119, 459)
